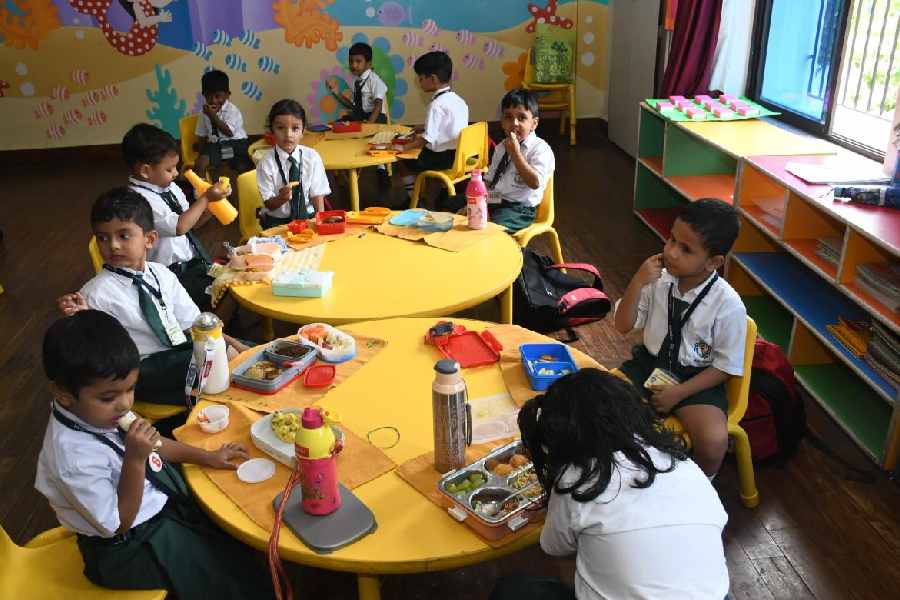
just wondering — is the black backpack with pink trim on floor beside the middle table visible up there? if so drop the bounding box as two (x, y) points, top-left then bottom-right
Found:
(513, 248), (612, 335)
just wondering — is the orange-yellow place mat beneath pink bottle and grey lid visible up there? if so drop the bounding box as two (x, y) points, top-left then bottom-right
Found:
(173, 402), (396, 531)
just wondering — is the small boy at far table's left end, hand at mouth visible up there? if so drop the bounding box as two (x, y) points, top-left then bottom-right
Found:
(194, 70), (253, 177)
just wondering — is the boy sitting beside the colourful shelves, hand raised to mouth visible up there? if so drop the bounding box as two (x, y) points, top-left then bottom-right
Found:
(615, 198), (747, 478)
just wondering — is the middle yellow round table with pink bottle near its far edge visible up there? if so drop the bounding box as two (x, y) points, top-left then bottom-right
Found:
(231, 225), (522, 330)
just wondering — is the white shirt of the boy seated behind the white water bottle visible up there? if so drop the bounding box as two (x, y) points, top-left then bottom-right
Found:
(81, 262), (200, 359)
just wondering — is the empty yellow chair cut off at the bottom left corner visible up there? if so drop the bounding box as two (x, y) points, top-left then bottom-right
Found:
(0, 527), (166, 600)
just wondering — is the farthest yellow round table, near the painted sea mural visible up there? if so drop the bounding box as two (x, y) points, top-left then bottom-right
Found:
(249, 123), (417, 210)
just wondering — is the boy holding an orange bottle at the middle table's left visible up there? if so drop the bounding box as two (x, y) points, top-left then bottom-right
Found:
(122, 123), (224, 310)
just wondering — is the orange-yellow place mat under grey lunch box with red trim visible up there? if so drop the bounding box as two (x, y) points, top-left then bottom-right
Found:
(209, 335), (387, 412)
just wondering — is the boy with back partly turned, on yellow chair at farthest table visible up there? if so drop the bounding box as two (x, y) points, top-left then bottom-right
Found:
(398, 52), (469, 198)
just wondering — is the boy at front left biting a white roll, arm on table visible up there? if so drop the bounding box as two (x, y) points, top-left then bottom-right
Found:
(35, 310), (272, 599)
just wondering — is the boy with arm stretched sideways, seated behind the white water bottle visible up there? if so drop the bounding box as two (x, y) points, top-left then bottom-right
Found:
(57, 187), (246, 405)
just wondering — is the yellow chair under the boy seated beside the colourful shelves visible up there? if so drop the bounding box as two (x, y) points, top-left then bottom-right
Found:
(611, 317), (759, 508)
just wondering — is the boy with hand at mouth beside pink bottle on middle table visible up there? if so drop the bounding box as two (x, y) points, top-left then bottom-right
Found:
(441, 90), (556, 233)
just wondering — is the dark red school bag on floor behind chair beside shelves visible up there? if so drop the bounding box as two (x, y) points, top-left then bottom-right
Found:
(741, 338), (806, 462)
